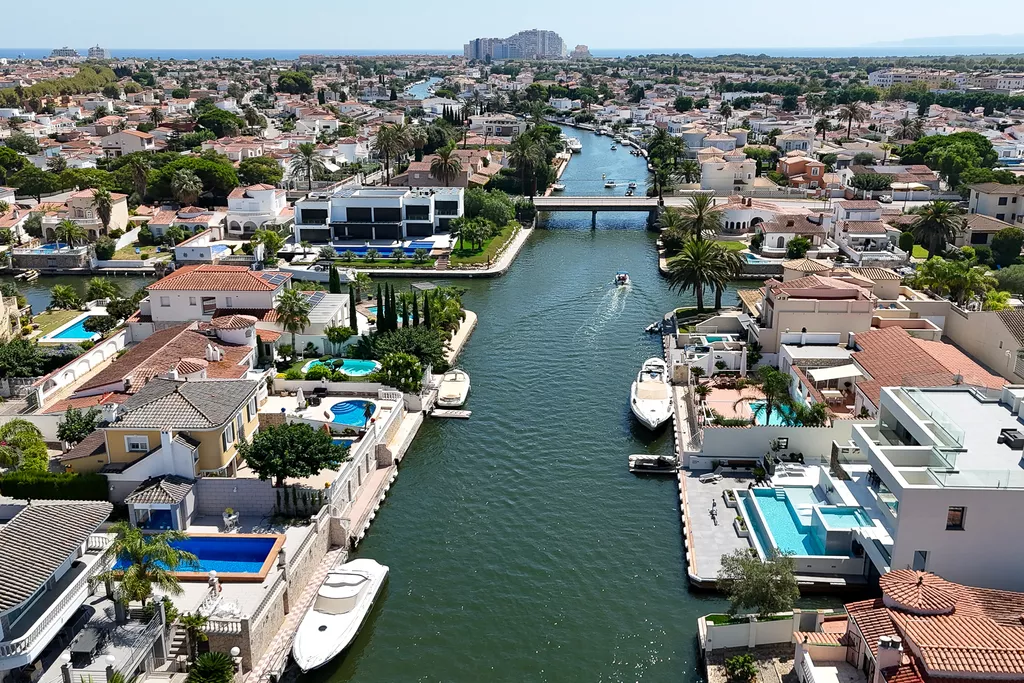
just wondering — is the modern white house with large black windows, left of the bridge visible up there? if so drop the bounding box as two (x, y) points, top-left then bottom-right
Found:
(294, 185), (465, 243)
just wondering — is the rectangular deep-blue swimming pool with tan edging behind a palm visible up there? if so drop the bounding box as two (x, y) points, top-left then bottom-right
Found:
(114, 533), (285, 581)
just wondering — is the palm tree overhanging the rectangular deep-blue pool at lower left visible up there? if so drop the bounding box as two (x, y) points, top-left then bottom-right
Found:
(96, 521), (198, 604)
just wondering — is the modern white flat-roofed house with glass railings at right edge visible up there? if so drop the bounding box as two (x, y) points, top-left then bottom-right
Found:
(852, 384), (1024, 591)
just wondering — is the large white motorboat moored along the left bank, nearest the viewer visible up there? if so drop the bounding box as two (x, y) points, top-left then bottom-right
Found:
(292, 558), (388, 672)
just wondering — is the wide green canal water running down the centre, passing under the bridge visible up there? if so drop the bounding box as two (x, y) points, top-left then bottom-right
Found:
(303, 125), (735, 683)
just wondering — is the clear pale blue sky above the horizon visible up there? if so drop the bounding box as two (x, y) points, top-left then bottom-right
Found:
(3, 0), (1024, 49)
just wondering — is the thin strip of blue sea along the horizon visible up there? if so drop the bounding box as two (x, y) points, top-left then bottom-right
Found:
(0, 45), (1024, 59)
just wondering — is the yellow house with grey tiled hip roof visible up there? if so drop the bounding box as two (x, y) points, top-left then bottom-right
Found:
(65, 378), (259, 478)
